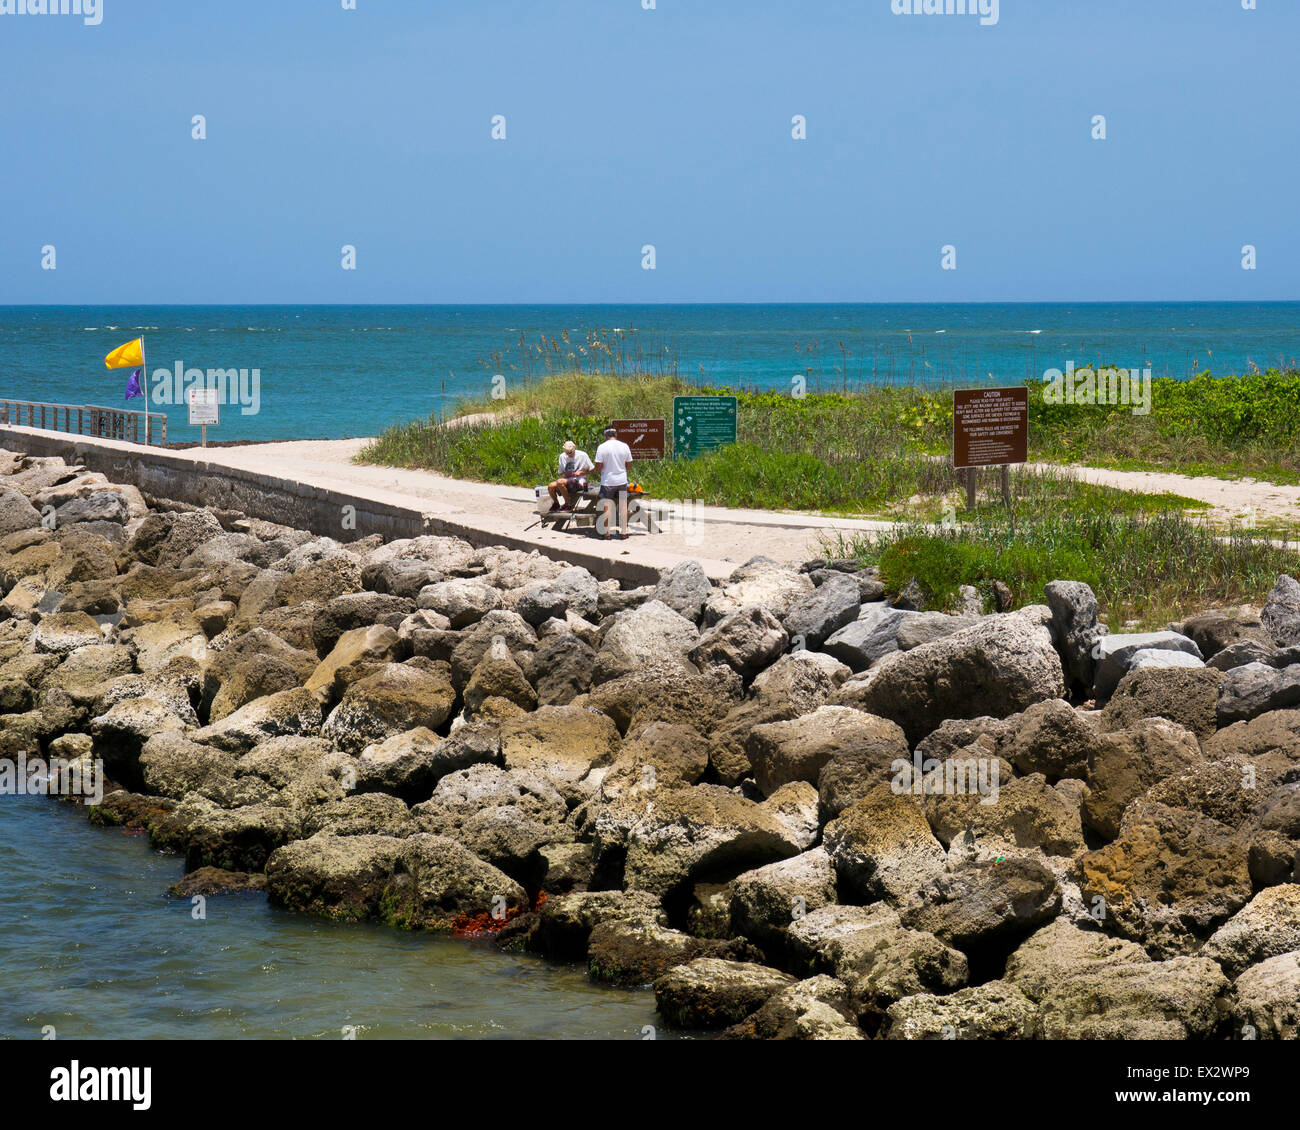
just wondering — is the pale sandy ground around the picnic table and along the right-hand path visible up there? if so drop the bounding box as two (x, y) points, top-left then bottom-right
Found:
(195, 440), (1300, 572)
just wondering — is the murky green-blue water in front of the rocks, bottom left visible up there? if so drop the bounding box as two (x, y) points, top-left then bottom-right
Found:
(0, 796), (673, 1040)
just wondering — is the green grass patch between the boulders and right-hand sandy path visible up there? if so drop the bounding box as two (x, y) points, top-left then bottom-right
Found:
(826, 511), (1300, 628)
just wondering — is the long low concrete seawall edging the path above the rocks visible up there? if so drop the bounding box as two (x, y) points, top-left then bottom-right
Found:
(0, 425), (736, 585)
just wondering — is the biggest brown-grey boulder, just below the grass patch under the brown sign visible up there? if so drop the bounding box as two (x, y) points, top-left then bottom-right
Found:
(858, 610), (1065, 744)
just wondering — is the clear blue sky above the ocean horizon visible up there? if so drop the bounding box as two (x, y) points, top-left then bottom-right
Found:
(0, 0), (1300, 303)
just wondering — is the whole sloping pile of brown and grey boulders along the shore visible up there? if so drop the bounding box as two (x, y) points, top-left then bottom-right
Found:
(0, 453), (1300, 1040)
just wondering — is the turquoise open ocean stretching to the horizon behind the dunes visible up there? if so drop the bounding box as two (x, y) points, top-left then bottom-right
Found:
(0, 303), (1300, 441)
